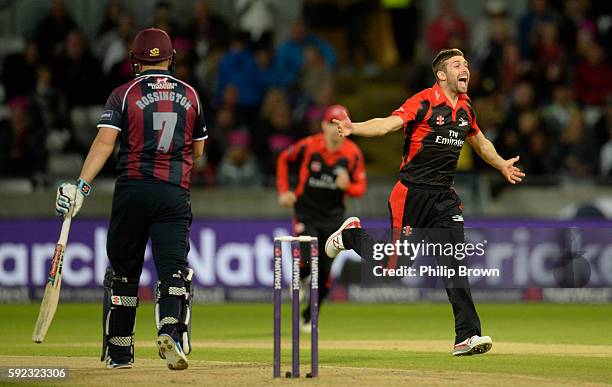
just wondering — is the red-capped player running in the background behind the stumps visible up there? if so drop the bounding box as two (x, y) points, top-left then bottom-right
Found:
(276, 105), (367, 333)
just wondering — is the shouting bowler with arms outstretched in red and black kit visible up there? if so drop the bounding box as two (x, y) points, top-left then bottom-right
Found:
(325, 49), (525, 356)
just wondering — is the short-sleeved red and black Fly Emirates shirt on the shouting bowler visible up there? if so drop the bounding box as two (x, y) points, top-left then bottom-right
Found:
(392, 83), (480, 187)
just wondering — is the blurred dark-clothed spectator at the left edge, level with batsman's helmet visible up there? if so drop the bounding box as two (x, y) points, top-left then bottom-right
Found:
(2, 42), (39, 100)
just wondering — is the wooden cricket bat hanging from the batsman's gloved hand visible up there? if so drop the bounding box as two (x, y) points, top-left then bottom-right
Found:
(32, 211), (72, 343)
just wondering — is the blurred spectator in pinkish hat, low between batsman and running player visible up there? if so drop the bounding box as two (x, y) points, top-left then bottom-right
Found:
(218, 131), (263, 187)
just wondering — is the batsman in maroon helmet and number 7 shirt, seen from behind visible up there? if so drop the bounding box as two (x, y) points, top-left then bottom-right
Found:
(56, 28), (207, 370)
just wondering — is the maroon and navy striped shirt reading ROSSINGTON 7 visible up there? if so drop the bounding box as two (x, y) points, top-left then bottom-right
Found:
(98, 70), (208, 189)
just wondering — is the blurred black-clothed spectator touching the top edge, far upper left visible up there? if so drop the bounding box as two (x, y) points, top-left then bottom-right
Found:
(35, 0), (77, 61)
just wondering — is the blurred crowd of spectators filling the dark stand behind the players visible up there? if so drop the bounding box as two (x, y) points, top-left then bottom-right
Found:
(0, 0), (612, 186)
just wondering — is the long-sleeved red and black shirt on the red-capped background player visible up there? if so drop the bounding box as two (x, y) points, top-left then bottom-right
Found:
(276, 133), (366, 219)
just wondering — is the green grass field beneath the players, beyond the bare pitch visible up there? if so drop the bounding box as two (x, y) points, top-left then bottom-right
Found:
(0, 304), (612, 385)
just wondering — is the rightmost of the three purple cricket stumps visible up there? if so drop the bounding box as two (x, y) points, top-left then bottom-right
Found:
(310, 239), (319, 378)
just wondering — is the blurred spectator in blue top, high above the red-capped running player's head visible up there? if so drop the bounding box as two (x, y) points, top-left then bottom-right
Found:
(276, 20), (336, 88)
